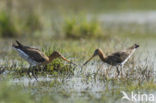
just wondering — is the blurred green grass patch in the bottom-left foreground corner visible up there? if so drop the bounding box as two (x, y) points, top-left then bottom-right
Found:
(0, 81), (33, 103)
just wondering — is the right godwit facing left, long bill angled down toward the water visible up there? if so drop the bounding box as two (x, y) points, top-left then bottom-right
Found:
(84, 44), (139, 76)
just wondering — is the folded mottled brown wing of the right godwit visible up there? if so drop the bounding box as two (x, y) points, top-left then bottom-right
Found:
(105, 51), (129, 65)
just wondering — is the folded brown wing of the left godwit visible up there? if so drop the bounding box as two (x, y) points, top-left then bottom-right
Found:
(21, 47), (48, 63)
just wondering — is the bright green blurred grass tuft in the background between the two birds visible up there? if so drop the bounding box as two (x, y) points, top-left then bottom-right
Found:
(64, 15), (104, 39)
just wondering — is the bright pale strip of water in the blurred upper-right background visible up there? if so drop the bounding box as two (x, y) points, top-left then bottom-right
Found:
(99, 11), (156, 25)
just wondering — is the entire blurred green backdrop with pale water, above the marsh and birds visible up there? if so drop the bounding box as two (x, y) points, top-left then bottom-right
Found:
(0, 0), (156, 39)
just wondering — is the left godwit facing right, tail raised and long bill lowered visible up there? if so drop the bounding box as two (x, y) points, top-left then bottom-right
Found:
(12, 40), (74, 67)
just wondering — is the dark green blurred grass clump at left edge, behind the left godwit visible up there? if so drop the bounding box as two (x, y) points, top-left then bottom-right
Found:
(0, 10), (42, 38)
